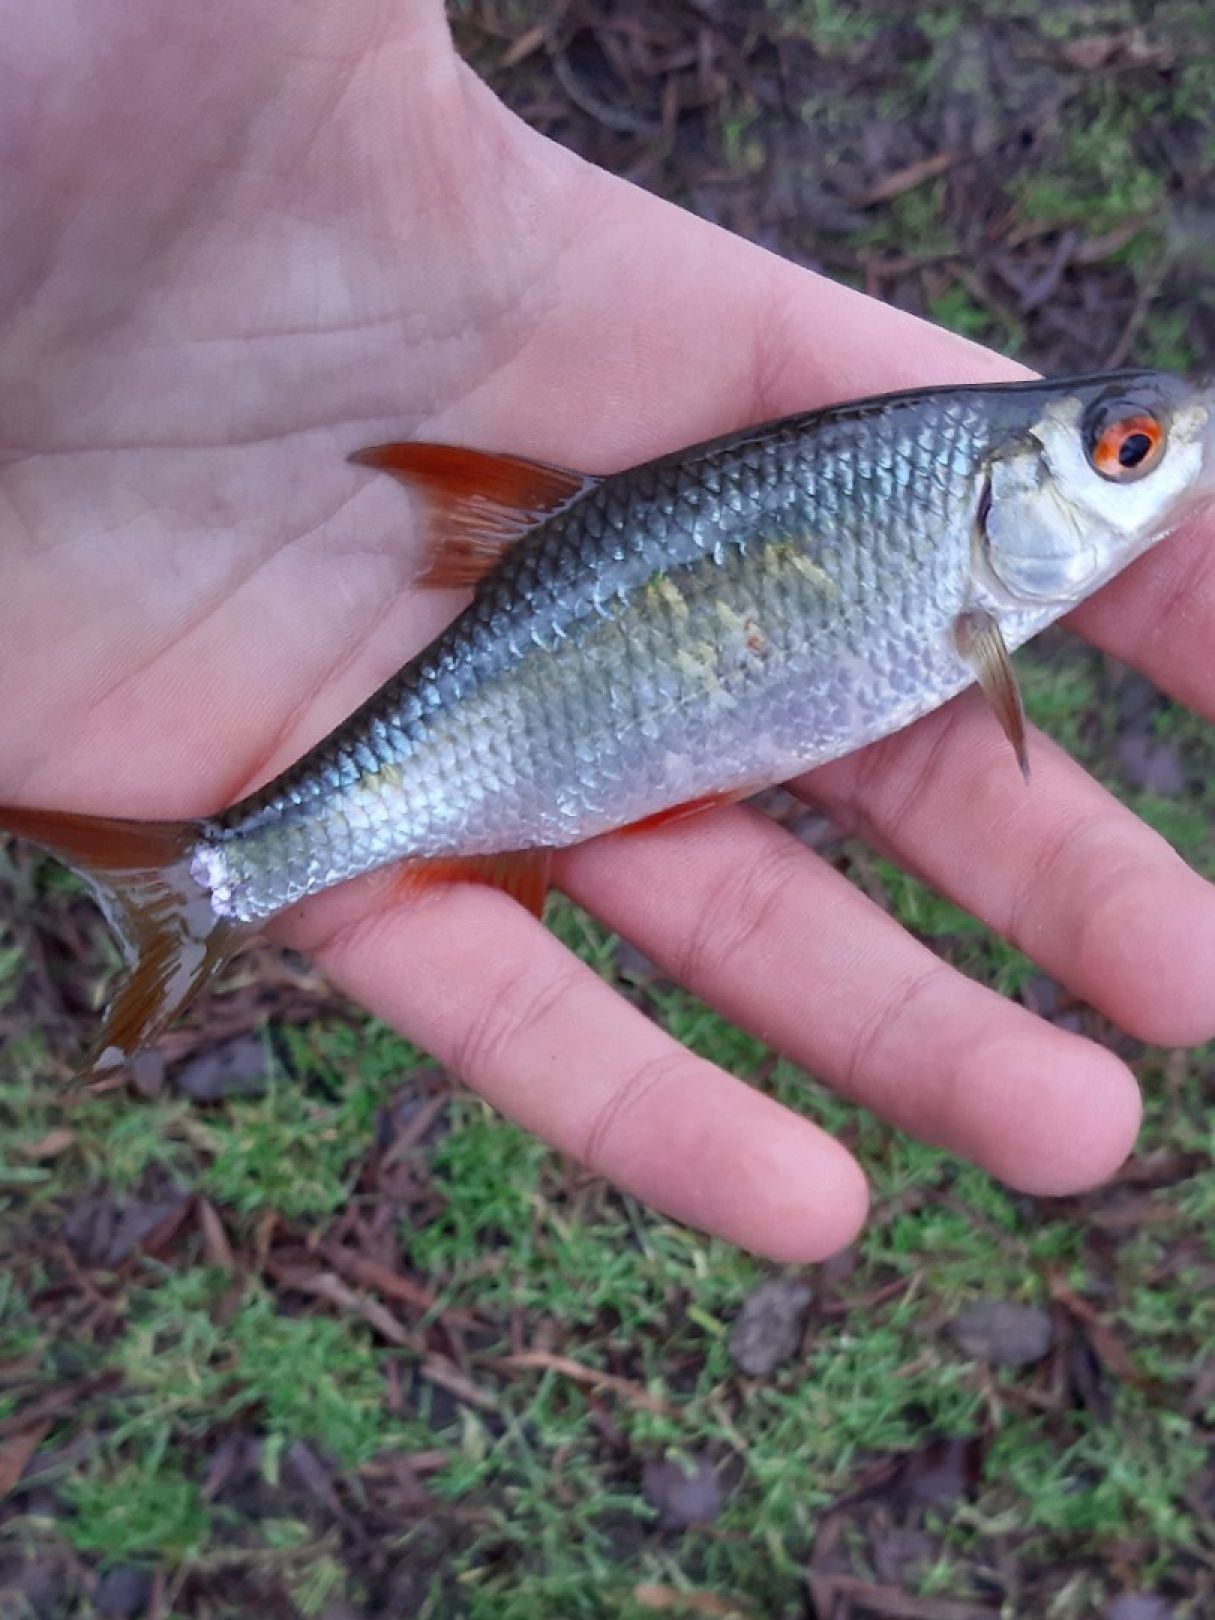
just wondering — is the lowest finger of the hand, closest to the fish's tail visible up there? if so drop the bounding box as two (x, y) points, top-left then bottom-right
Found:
(280, 885), (867, 1260)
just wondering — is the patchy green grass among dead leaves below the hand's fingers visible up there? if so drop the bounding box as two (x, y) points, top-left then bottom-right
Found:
(0, 855), (1215, 1620)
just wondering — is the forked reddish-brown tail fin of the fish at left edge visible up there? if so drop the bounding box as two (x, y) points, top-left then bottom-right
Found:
(0, 805), (246, 1074)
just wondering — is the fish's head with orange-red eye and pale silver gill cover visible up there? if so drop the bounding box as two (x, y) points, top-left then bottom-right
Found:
(978, 371), (1215, 606)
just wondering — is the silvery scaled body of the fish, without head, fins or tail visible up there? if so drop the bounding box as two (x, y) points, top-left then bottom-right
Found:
(204, 390), (1040, 920)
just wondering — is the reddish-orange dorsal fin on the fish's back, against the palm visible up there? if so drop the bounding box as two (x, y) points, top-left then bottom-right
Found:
(350, 444), (599, 585)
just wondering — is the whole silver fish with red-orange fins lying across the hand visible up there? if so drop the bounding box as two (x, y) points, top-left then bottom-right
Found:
(0, 369), (1215, 1071)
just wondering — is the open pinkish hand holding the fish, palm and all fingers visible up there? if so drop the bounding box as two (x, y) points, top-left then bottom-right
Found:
(0, 0), (1215, 1259)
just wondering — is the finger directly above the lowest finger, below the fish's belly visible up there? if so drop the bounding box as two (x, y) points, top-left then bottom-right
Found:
(562, 808), (1139, 1192)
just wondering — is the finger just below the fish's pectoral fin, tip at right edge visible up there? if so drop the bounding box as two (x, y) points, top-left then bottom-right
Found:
(795, 693), (1215, 1045)
